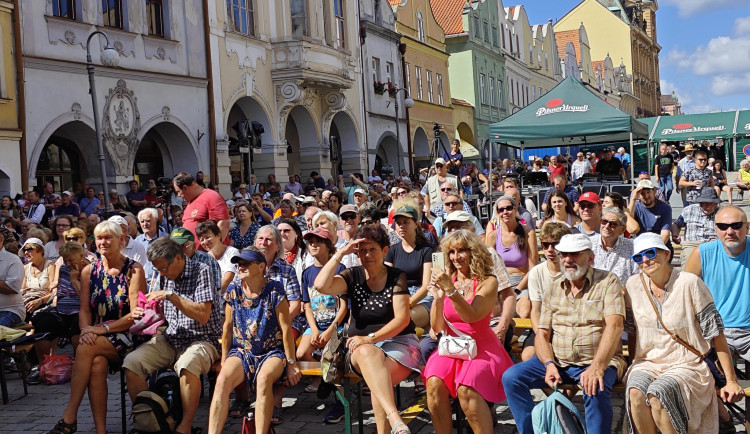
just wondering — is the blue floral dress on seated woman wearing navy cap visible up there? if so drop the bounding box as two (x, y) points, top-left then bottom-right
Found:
(224, 279), (286, 387)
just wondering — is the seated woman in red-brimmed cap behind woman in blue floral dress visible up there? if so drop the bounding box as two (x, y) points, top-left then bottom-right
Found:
(297, 227), (349, 392)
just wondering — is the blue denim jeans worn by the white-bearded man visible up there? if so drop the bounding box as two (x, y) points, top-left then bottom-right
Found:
(503, 356), (617, 434)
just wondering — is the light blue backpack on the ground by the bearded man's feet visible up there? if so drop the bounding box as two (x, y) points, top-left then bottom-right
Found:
(531, 387), (586, 434)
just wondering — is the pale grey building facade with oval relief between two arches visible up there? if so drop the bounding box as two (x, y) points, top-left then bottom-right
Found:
(19, 0), (211, 192)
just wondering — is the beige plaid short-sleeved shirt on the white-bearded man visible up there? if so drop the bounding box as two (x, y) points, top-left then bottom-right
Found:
(539, 267), (626, 378)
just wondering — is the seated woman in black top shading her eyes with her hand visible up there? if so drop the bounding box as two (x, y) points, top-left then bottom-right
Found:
(314, 225), (423, 434)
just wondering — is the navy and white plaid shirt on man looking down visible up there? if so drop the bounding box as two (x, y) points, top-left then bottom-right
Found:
(159, 257), (223, 351)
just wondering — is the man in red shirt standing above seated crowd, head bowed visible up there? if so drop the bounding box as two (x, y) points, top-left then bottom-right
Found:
(172, 172), (229, 249)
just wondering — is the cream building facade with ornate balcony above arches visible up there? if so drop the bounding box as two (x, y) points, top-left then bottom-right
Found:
(208, 0), (367, 193)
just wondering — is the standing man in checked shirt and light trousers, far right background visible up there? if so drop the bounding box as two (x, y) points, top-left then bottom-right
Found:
(672, 187), (721, 268)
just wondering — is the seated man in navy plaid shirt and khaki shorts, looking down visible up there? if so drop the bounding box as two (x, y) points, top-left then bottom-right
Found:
(122, 237), (222, 433)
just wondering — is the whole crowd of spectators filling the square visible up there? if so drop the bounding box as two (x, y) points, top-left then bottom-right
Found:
(0, 142), (750, 434)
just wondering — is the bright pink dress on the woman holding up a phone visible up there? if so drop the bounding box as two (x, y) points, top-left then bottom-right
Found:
(422, 279), (513, 403)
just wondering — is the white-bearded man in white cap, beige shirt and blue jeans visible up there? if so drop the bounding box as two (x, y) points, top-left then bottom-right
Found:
(503, 234), (626, 434)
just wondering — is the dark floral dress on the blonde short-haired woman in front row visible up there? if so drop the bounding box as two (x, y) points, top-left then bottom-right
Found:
(89, 258), (142, 358)
